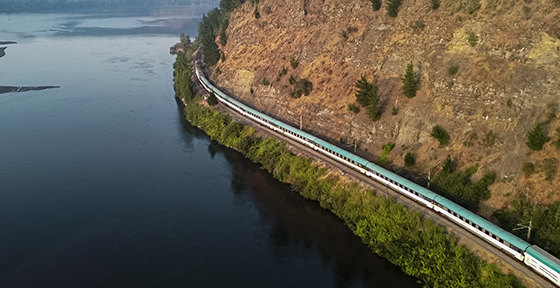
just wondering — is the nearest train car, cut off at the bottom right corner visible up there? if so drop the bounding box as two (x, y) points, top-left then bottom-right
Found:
(525, 245), (560, 286)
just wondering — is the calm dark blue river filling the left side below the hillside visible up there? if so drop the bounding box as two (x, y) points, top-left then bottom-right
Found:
(0, 7), (417, 287)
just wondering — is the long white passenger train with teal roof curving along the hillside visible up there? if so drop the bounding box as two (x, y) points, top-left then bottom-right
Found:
(195, 61), (560, 287)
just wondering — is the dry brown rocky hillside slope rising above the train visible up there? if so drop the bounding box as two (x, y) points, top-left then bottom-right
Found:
(213, 0), (560, 210)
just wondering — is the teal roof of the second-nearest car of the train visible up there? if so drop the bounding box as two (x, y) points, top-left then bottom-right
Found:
(434, 196), (531, 251)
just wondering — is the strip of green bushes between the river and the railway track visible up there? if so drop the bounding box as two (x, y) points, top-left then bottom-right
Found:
(175, 46), (544, 287)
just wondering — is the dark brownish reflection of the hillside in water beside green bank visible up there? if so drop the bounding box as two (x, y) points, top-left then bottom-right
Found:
(208, 142), (419, 287)
